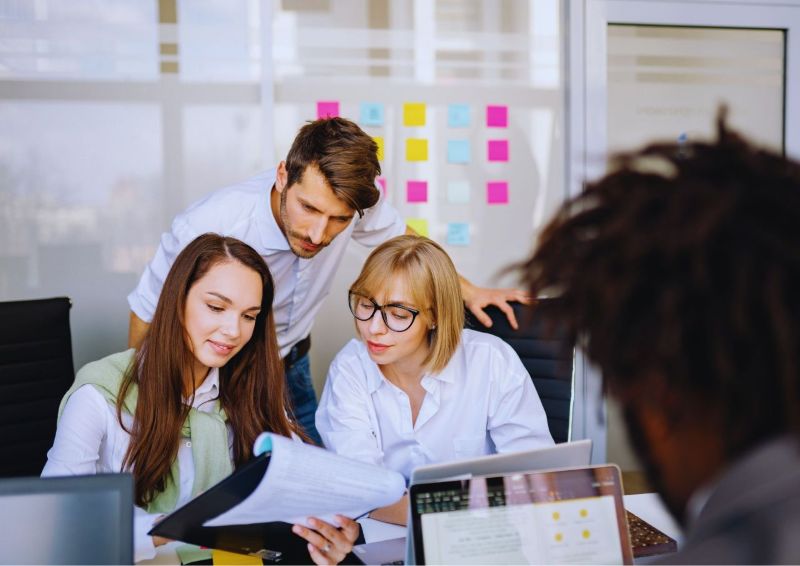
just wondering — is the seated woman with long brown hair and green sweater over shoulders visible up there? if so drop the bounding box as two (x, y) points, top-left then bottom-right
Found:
(42, 234), (358, 563)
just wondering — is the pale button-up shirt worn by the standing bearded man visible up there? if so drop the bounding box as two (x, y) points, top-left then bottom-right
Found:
(128, 169), (406, 356)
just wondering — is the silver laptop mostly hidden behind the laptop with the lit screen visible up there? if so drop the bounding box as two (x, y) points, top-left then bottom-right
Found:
(354, 439), (592, 564)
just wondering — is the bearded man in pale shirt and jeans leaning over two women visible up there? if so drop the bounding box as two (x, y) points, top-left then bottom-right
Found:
(128, 118), (527, 443)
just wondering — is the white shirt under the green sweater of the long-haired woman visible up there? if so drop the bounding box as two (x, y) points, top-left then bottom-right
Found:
(42, 368), (227, 562)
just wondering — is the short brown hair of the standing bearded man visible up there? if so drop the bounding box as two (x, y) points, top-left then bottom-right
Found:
(286, 118), (381, 215)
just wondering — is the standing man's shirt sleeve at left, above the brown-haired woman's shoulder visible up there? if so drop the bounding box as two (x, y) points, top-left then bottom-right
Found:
(128, 216), (200, 323)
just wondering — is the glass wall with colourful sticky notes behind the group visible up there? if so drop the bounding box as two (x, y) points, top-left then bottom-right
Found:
(0, 0), (565, 390)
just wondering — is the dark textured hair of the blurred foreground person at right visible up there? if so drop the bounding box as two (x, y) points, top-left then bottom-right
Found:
(525, 112), (800, 461)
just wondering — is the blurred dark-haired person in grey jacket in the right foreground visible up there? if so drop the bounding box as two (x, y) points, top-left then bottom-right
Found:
(524, 112), (800, 564)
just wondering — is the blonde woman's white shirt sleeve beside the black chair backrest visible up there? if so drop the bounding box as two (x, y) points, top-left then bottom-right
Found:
(488, 344), (554, 453)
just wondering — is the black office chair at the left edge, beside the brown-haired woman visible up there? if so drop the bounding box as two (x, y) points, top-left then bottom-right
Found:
(0, 297), (75, 477)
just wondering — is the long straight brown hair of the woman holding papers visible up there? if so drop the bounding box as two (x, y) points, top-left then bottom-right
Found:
(117, 234), (302, 506)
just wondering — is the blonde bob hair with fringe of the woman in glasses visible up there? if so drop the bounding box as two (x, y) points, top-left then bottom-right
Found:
(350, 236), (464, 373)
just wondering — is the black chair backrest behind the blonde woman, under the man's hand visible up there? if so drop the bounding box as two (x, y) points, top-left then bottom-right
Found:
(466, 299), (575, 442)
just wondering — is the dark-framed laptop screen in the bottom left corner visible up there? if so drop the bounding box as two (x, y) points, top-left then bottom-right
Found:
(0, 474), (133, 564)
